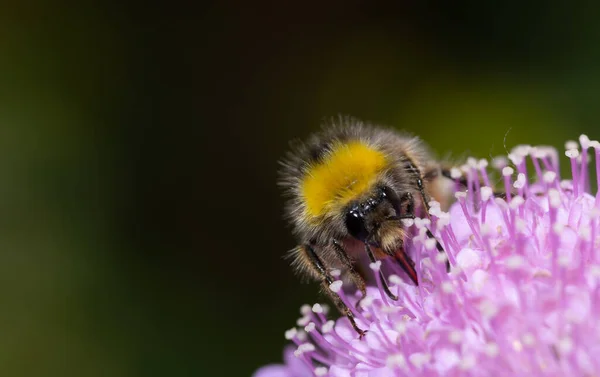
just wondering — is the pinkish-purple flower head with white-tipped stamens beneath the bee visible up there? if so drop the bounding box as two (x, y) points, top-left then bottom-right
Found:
(255, 136), (600, 377)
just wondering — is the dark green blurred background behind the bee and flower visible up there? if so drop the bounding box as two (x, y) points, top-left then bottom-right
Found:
(0, 0), (600, 377)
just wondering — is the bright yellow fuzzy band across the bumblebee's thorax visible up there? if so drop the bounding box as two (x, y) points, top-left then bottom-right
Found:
(301, 141), (387, 218)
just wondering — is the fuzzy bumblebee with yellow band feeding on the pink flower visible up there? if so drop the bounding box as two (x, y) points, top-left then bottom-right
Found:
(279, 117), (450, 336)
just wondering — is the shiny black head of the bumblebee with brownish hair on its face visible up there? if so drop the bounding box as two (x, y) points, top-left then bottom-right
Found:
(345, 186), (402, 249)
